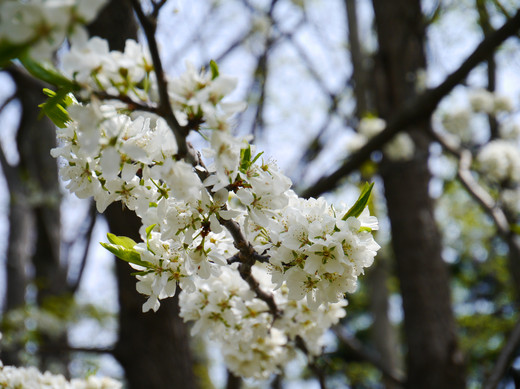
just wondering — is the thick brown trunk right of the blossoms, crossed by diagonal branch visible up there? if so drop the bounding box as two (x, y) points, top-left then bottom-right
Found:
(373, 0), (465, 389)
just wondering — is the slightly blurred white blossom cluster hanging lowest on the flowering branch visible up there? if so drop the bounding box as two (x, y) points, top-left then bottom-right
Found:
(179, 264), (347, 379)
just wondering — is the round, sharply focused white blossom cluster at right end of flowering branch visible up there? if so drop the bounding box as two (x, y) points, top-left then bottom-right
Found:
(246, 193), (379, 309)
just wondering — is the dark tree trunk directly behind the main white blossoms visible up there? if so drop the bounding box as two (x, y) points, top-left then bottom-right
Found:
(89, 0), (199, 389)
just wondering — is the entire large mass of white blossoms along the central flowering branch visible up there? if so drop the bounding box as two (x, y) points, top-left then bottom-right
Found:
(47, 34), (379, 378)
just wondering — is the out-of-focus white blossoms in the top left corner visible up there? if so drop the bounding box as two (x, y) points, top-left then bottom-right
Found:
(0, 0), (106, 59)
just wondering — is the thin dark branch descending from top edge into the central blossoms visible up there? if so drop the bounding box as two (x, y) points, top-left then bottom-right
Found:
(130, 0), (195, 163)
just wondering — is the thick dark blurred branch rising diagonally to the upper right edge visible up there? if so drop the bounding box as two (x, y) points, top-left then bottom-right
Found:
(301, 9), (520, 198)
